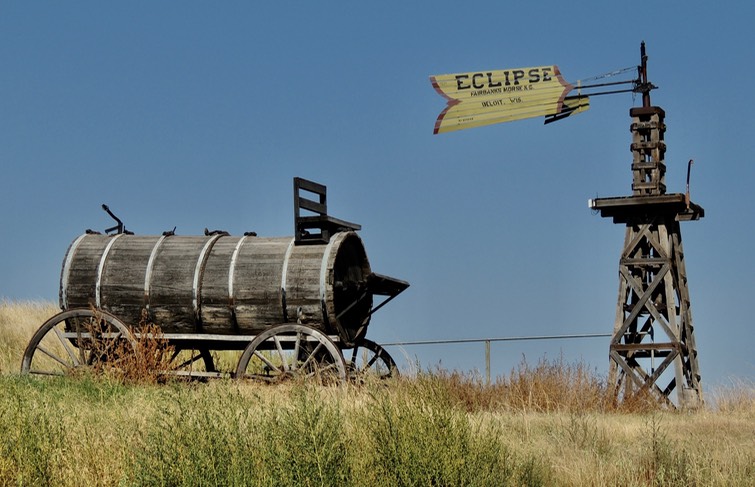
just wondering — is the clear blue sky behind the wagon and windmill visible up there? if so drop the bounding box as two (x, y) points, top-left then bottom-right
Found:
(0, 1), (755, 387)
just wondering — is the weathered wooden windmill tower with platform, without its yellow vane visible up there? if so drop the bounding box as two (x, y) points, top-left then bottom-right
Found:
(589, 42), (705, 409)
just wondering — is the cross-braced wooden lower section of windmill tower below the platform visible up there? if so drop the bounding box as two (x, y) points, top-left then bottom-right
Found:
(609, 214), (703, 408)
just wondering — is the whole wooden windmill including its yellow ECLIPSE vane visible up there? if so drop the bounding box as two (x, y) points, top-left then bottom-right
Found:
(430, 42), (705, 408)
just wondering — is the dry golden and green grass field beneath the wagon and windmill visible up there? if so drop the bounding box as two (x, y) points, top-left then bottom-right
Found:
(0, 303), (755, 486)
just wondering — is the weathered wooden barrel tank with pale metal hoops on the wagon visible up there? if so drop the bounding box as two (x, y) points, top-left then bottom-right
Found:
(60, 231), (372, 341)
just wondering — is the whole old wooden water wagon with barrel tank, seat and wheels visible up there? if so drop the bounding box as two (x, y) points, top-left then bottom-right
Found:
(22, 178), (409, 381)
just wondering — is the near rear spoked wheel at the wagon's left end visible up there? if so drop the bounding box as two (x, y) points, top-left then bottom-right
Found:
(21, 309), (136, 376)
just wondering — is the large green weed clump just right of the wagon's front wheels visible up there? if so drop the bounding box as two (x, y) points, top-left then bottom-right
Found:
(364, 377), (513, 486)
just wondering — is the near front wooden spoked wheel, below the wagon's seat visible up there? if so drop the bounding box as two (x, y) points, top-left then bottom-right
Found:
(236, 323), (346, 383)
